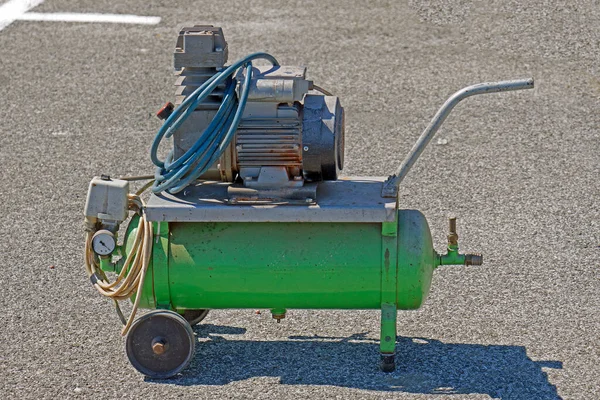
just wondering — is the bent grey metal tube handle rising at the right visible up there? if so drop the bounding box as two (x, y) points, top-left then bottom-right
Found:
(381, 78), (533, 197)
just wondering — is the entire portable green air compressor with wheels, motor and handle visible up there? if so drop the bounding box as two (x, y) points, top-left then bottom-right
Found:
(84, 26), (533, 378)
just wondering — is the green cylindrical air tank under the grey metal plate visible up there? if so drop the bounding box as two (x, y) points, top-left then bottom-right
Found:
(128, 210), (439, 311)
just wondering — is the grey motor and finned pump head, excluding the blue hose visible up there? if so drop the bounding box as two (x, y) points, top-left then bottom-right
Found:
(173, 25), (344, 190)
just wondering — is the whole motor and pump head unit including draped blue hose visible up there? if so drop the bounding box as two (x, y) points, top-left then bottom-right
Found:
(153, 25), (344, 200)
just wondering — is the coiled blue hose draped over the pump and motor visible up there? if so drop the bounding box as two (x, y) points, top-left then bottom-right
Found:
(150, 53), (279, 193)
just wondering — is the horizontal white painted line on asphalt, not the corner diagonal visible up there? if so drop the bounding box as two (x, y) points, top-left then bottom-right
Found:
(18, 12), (160, 25)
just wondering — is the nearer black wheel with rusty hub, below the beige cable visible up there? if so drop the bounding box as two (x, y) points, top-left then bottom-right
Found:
(125, 310), (196, 379)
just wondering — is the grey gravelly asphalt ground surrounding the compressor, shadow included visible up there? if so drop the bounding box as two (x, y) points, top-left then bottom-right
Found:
(0, 0), (600, 399)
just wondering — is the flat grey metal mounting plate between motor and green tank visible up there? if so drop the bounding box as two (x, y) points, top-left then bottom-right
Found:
(146, 177), (396, 223)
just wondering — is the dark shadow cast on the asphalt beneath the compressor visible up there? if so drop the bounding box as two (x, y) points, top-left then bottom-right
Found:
(153, 325), (562, 399)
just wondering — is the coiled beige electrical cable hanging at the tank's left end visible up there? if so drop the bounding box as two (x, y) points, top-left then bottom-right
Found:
(85, 194), (153, 336)
